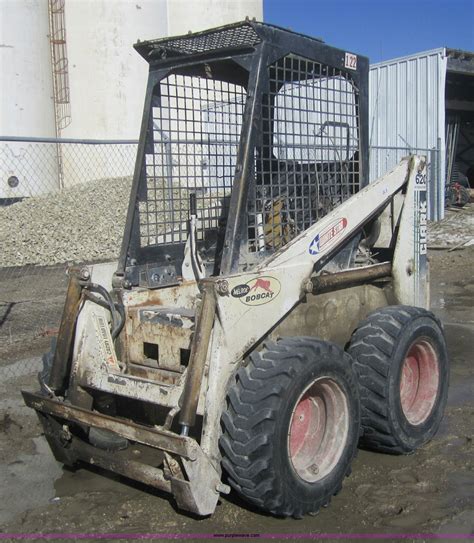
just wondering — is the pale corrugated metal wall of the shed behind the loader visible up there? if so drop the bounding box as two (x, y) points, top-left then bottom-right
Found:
(369, 48), (446, 219)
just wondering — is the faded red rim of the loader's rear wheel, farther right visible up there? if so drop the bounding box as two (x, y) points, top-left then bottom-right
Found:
(400, 339), (439, 426)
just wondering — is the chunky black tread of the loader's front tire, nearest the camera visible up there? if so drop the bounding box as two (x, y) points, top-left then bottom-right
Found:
(220, 337), (357, 518)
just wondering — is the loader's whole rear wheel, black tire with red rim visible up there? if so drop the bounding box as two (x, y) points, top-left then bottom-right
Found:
(349, 305), (449, 454)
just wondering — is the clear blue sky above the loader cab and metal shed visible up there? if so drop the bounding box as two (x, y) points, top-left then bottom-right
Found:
(263, 0), (474, 63)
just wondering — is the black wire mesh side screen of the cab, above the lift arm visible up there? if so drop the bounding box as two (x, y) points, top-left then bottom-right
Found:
(249, 55), (359, 254)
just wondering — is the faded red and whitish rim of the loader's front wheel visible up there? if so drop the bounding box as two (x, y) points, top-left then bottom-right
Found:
(288, 377), (349, 482)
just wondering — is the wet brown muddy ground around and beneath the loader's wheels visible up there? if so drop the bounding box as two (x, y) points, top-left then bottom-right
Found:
(0, 247), (474, 534)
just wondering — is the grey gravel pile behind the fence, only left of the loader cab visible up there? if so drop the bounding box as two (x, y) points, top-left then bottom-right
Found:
(0, 177), (131, 267)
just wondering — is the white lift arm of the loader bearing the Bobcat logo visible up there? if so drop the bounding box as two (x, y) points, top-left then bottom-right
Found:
(201, 157), (424, 457)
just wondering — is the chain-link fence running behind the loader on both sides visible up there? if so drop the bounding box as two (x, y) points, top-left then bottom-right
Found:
(0, 138), (440, 376)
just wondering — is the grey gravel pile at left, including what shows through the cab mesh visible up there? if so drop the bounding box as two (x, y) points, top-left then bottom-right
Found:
(0, 177), (228, 268)
